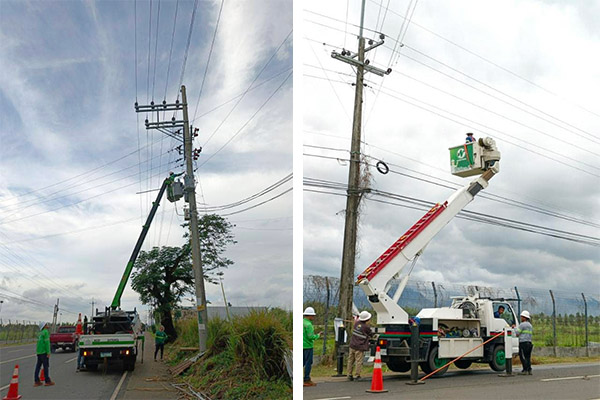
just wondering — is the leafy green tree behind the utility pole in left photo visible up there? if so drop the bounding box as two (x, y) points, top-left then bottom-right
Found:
(131, 214), (237, 341)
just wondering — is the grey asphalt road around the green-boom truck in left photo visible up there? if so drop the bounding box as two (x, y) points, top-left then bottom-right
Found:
(0, 344), (130, 400)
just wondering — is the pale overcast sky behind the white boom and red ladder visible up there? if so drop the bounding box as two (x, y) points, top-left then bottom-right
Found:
(304, 0), (600, 304)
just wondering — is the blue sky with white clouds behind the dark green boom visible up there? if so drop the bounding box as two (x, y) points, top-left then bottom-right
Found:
(0, 0), (292, 321)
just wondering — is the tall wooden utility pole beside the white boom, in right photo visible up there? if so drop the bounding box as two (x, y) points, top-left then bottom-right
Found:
(331, 0), (392, 329)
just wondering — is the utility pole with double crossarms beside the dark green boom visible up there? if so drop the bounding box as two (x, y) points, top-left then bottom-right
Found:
(135, 85), (208, 352)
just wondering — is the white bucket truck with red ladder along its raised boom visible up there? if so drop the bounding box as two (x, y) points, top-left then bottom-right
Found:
(356, 138), (519, 375)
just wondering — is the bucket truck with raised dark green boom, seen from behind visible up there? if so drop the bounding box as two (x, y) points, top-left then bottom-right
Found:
(79, 173), (183, 371)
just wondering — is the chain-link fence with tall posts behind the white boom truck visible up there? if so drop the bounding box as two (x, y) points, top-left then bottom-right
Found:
(303, 275), (600, 347)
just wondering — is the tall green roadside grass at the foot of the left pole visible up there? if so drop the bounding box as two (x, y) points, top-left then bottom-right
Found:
(167, 309), (292, 399)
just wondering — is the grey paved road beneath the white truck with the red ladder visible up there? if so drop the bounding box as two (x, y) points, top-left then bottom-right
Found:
(304, 363), (600, 400)
